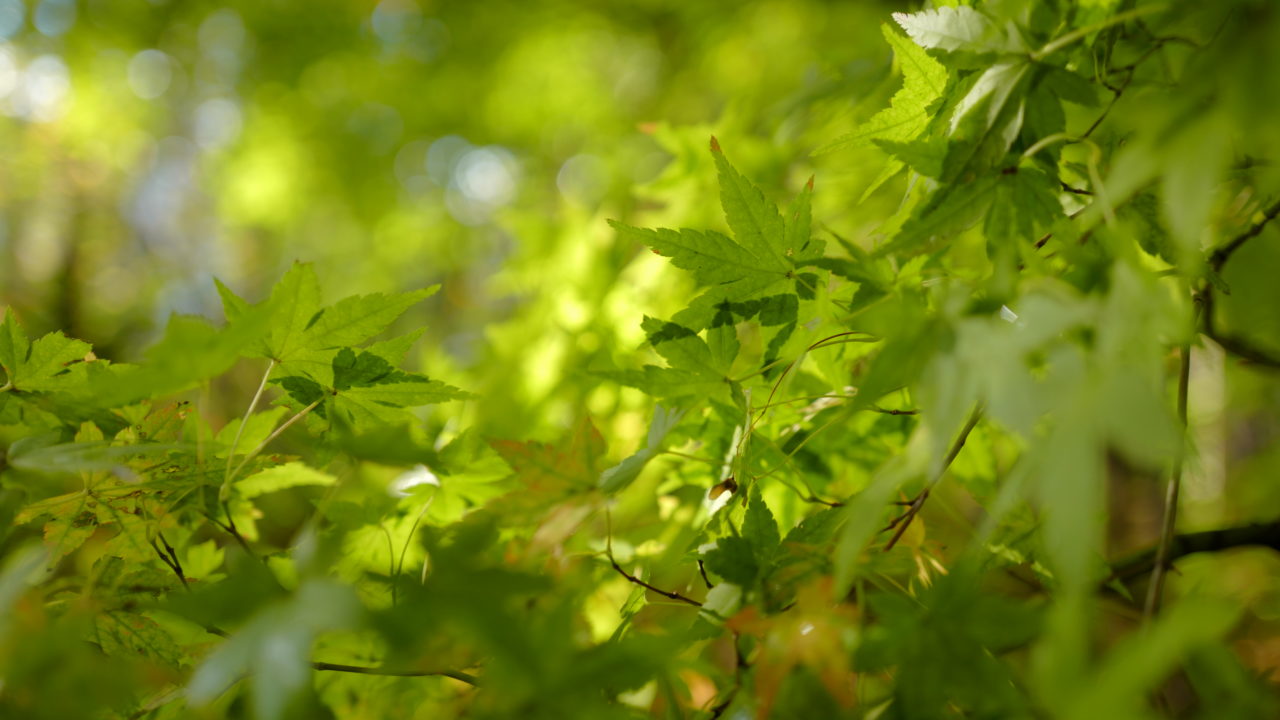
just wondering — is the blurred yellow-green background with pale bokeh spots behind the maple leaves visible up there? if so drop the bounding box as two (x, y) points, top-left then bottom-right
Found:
(0, 0), (899, 438)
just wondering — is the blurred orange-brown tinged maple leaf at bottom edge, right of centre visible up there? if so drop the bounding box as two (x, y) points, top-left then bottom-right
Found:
(726, 577), (858, 719)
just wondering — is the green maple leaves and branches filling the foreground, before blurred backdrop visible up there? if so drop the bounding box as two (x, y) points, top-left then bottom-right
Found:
(0, 0), (1280, 720)
